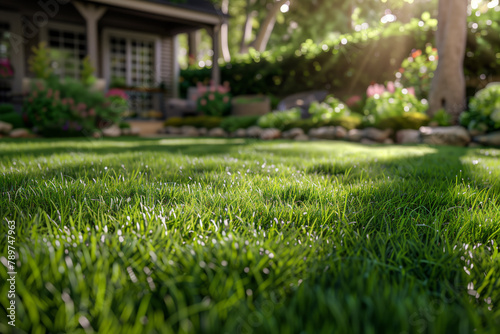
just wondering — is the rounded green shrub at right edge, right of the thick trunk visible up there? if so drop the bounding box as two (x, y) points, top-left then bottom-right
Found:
(460, 83), (500, 132)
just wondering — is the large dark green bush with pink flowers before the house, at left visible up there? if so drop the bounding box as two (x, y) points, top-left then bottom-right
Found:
(23, 77), (123, 136)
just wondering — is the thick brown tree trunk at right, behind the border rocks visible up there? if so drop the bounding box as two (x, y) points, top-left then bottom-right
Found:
(427, 0), (467, 124)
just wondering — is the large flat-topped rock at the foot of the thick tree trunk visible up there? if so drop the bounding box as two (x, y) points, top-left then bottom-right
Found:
(419, 126), (470, 146)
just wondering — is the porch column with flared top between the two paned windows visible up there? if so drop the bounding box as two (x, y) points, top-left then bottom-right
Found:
(74, 1), (107, 74)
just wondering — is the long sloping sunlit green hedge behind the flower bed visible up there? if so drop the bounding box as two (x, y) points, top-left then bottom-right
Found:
(180, 17), (437, 97)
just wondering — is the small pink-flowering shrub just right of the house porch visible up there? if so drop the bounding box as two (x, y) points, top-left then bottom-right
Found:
(196, 82), (231, 117)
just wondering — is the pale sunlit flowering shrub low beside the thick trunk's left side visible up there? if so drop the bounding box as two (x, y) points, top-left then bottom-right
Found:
(364, 82), (427, 127)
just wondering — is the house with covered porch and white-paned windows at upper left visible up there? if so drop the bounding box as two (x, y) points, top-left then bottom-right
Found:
(0, 0), (224, 122)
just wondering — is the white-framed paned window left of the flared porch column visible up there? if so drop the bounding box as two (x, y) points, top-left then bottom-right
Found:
(46, 24), (87, 79)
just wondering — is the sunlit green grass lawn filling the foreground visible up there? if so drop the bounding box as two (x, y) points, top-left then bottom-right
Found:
(0, 139), (500, 334)
